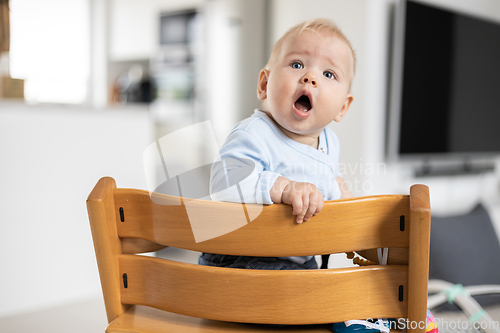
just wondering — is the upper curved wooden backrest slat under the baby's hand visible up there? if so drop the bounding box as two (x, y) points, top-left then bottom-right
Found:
(115, 189), (409, 256)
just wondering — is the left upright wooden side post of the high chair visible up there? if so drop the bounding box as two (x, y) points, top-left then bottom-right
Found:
(87, 177), (128, 323)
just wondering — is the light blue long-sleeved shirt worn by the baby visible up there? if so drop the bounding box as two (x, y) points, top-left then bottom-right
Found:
(210, 110), (341, 264)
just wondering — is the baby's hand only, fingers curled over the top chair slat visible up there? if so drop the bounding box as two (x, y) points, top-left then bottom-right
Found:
(281, 181), (324, 223)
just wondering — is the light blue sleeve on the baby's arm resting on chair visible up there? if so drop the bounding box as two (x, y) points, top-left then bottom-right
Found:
(210, 130), (280, 204)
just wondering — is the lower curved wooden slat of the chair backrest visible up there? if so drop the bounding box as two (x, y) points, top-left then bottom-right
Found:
(120, 255), (408, 324)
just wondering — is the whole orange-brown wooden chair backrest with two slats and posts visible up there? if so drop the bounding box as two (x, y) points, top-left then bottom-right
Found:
(87, 177), (430, 332)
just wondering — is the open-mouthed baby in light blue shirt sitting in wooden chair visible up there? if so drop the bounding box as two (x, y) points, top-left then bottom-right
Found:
(199, 19), (356, 269)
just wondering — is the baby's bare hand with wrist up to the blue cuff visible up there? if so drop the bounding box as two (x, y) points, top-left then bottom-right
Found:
(270, 176), (324, 223)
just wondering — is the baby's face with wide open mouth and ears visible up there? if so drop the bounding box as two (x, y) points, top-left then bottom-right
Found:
(258, 30), (353, 141)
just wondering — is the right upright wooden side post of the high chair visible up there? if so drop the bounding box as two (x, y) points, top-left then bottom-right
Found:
(407, 185), (431, 333)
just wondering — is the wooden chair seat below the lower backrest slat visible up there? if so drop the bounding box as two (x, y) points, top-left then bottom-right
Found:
(106, 305), (332, 333)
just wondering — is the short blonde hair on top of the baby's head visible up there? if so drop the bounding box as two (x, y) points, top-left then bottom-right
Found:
(265, 18), (356, 81)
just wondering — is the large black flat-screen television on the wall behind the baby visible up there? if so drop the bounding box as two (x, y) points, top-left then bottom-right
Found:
(387, 0), (500, 171)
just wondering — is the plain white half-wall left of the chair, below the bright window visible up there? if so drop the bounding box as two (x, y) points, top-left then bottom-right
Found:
(0, 102), (153, 317)
